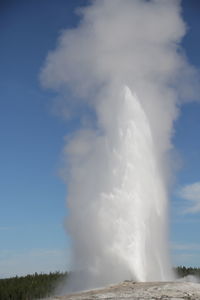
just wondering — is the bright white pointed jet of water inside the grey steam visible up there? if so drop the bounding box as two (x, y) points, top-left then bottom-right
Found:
(102, 87), (172, 281)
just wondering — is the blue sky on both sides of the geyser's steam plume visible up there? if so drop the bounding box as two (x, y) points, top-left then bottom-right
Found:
(0, 0), (200, 277)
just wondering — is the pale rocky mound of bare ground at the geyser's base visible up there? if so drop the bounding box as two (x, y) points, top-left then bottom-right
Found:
(51, 281), (200, 300)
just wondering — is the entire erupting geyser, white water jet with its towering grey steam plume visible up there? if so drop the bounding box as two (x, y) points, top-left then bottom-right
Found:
(41, 0), (198, 289)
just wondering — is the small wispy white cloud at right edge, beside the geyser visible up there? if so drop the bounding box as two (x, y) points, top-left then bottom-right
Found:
(178, 182), (200, 214)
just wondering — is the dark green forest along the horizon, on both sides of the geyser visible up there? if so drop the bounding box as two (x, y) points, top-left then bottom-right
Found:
(0, 266), (200, 300)
